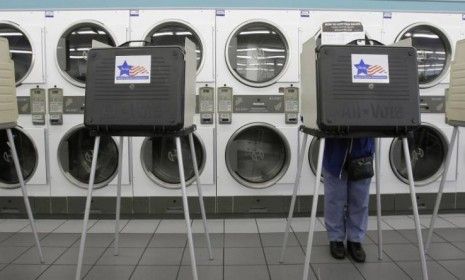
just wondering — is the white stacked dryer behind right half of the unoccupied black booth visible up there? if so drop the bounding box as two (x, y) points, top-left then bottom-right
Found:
(130, 10), (216, 197)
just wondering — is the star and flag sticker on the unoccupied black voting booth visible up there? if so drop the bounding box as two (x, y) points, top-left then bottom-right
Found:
(115, 55), (152, 84)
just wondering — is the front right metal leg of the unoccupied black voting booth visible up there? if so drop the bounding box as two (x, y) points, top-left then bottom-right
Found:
(175, 136), (198, 280)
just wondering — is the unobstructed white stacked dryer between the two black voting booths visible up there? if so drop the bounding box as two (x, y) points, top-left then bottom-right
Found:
(216, 10), (300, 212)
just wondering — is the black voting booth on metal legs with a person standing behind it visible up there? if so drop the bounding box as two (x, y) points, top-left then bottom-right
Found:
(280, 38), (428, 280)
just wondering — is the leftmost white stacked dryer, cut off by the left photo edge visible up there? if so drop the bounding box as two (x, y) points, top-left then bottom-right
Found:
(0, 11), (50, 212)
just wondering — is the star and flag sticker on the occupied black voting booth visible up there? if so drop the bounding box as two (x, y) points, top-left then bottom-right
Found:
(352, 54), (389, 84)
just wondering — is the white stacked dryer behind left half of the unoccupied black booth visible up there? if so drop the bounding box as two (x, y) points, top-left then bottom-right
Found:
(45, 10), (133, 201)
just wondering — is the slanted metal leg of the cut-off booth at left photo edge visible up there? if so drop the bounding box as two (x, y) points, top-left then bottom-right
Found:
(6, 128), (44, 263)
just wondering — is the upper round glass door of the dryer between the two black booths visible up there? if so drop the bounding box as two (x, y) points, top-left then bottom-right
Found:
(226, 22), (289, 87)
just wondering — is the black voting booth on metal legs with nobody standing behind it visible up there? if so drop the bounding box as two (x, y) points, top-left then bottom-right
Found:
(76, 39), (213, 280)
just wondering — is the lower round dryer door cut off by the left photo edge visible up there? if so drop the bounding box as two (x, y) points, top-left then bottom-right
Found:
(0, 128), (39, 188)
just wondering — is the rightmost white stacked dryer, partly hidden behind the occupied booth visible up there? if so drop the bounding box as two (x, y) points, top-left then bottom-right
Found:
(381, 13), (462, 203)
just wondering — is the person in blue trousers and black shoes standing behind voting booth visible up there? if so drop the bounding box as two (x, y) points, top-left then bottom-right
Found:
(323, 138), (375, 262)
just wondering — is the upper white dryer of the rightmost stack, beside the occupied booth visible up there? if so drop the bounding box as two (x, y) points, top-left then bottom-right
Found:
(382, 12), (463, 95)
